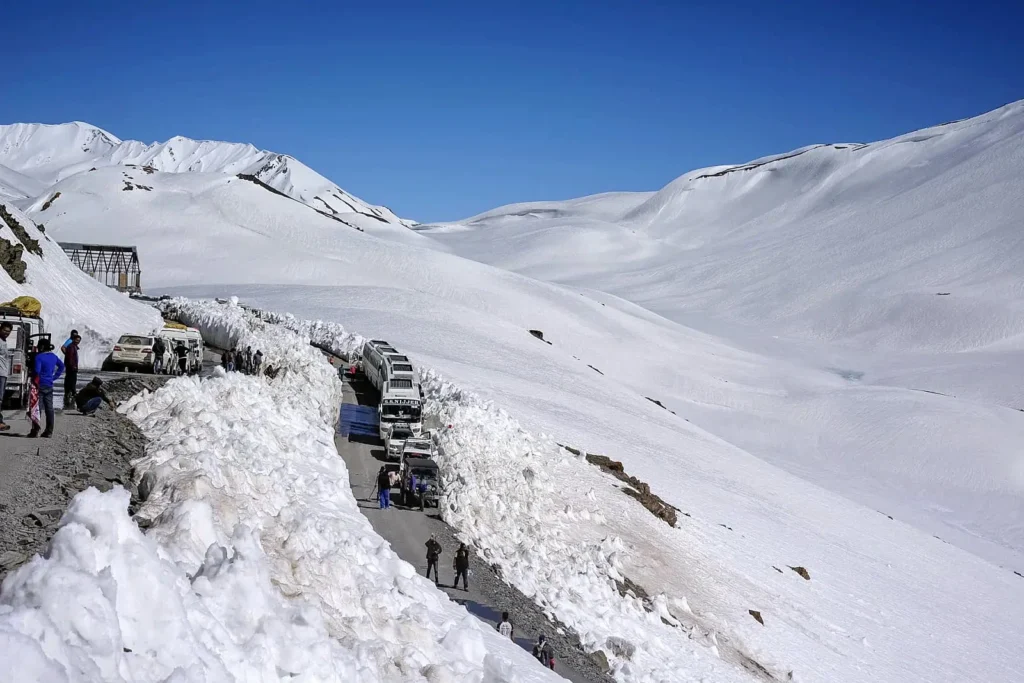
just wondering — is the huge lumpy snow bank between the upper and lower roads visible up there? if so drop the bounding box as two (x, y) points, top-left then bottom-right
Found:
(0, 301), (554, 682)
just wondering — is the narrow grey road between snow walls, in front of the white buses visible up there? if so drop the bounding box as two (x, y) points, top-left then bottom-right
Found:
(335, 378), (611, 683)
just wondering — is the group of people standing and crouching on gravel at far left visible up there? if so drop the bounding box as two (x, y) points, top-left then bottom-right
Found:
(0, 322), (113, 438)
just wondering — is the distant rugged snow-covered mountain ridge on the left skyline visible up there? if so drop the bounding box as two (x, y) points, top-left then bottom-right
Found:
(0, 122), (410, 224)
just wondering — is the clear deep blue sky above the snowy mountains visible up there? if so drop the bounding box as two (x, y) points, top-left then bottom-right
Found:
(0, 0), (1024, 220)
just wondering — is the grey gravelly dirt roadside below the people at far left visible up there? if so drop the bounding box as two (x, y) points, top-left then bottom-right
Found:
(0, 377), (166, 579)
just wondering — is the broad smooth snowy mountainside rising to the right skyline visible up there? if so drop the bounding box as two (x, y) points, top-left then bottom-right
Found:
(421, 101), (1024, 358)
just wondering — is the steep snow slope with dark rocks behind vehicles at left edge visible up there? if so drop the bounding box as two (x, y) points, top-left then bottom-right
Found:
(0, 202), (163, 368)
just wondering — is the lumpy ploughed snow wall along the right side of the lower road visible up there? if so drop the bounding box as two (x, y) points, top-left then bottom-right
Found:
(253, 301), (749, 682)
